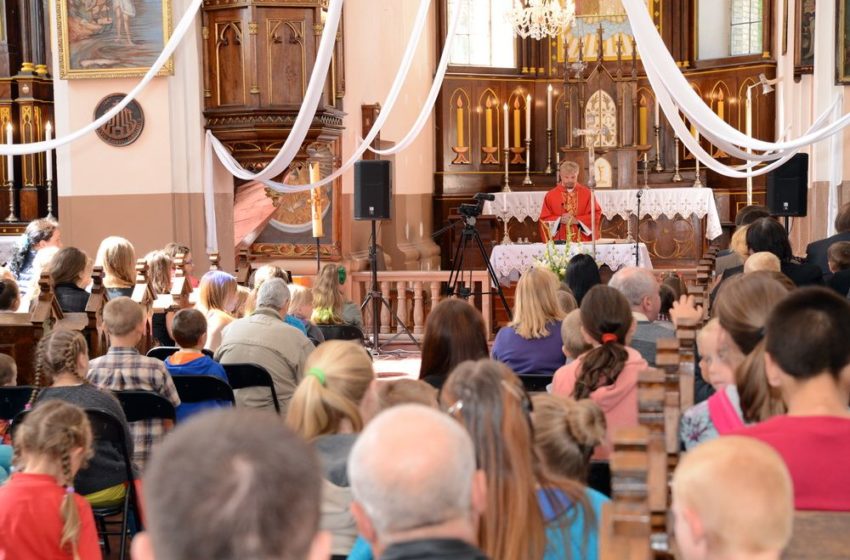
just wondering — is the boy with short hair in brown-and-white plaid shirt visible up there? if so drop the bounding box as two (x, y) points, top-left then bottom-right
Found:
(87, 296), (180, 469)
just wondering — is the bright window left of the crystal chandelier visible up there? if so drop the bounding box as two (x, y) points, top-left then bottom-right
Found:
(446, 0), (516, 68)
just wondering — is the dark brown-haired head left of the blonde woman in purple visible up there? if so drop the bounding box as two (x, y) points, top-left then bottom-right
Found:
(419, 298), (489, 389)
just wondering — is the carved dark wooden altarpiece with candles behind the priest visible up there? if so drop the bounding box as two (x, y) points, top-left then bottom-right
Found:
(433, 0), (776, 268)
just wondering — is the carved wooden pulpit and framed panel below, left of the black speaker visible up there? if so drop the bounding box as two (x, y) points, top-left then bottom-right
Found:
(203, 0), (345, 258)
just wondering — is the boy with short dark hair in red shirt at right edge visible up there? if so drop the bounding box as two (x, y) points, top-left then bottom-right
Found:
(739, 288), (850, 511)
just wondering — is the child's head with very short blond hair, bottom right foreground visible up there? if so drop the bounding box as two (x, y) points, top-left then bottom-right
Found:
(672, 437), (794, 560)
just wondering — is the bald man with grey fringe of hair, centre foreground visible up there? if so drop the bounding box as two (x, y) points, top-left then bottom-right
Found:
(348, 405), (487, 560)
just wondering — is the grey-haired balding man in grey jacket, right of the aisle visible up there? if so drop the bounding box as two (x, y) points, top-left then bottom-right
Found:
(608, 266), (676, 366)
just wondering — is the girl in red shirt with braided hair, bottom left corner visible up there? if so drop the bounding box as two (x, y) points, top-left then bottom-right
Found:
(0, 401), (101, 560)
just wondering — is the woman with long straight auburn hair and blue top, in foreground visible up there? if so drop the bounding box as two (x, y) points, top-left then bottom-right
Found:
(440, 360), (605, 560)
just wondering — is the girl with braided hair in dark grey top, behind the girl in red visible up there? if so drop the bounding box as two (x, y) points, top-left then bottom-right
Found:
(30, 329), (133, 507)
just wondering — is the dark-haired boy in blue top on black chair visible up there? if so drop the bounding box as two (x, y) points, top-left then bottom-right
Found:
(165, 309), (230, 422)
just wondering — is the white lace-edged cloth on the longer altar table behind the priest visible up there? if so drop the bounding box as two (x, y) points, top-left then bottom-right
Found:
(483, 187), (723, 240)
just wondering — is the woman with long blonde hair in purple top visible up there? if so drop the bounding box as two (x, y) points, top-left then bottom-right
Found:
(493, 268), (566, 375)
